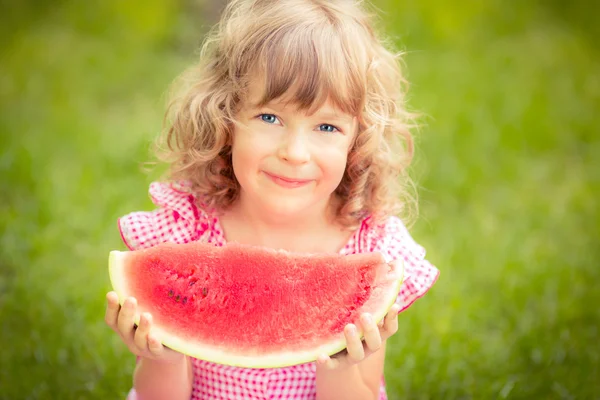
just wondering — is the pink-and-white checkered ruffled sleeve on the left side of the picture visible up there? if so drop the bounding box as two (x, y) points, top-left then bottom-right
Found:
(118, 182), (208, 250)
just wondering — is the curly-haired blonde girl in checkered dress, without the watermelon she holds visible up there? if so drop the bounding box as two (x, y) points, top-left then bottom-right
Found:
(106, 0), (438, 400)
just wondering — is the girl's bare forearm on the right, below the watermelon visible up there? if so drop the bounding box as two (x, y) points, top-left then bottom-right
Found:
(317, 342), (385, 400)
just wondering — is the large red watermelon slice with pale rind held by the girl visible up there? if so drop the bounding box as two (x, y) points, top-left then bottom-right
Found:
(109, 242), (403, 368)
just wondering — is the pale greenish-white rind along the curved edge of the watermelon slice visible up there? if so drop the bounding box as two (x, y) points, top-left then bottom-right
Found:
(109, 251), (405, 368)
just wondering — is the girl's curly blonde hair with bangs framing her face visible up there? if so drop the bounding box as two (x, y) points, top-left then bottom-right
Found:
(159, 0), (416, 227)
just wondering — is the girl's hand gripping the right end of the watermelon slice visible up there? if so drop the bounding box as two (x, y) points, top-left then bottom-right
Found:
(317, 304), (400, 369)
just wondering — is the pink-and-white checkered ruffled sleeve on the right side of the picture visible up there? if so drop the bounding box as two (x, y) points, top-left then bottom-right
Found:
(363, 217), (440, 311)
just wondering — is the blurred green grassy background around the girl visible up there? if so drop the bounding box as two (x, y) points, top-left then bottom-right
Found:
(0, 0), (600, 400)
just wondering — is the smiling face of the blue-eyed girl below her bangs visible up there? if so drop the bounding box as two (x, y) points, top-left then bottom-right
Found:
(232, 83), (357, 218)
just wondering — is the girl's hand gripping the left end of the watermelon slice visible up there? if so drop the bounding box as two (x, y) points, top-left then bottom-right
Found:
(104, 292), (185, 363)
